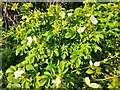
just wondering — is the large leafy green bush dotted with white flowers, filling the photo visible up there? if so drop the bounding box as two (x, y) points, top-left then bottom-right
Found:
(2, 2), (120, 89)
